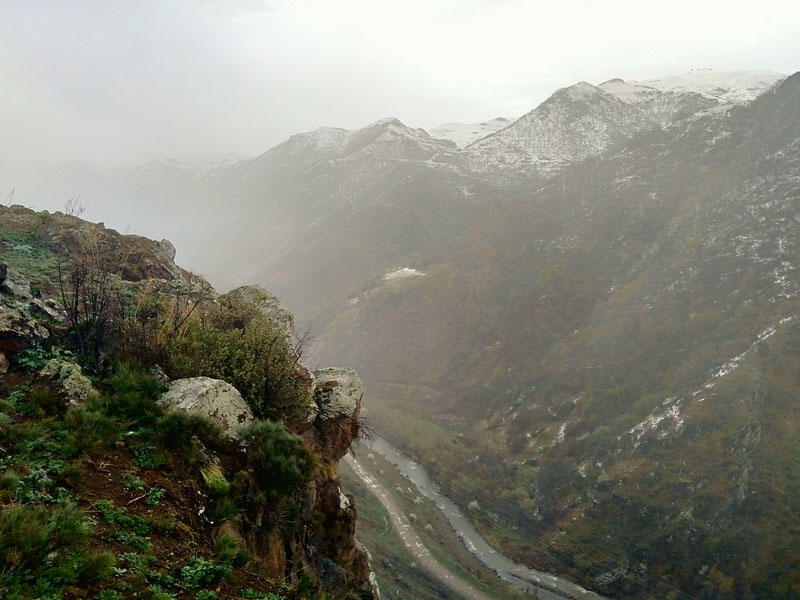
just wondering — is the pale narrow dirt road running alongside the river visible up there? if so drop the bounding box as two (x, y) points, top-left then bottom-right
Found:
(345, 456), (494, 600)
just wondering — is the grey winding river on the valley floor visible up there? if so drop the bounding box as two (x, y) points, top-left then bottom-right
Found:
(368, 436), (603, 600)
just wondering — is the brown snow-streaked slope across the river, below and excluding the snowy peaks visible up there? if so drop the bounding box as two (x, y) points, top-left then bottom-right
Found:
(304, 70), (800, 598)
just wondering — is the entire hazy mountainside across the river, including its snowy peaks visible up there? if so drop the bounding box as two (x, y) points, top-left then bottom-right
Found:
(7, 67), (800, 600)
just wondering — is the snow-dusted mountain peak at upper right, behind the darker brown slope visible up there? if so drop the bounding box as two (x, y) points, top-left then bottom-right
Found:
(466, 69), (783, 178)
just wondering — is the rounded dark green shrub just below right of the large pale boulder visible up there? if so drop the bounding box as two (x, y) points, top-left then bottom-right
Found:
(241, 421), (314, 502)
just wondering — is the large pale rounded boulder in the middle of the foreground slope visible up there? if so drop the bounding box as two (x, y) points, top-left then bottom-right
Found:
(159, 377), (253, 438)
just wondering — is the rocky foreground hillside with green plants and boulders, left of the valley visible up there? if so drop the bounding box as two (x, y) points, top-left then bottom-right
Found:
(0, 206), (378, 600)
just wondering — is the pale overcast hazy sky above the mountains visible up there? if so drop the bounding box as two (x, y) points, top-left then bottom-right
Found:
(0, 0), (800, 183)
